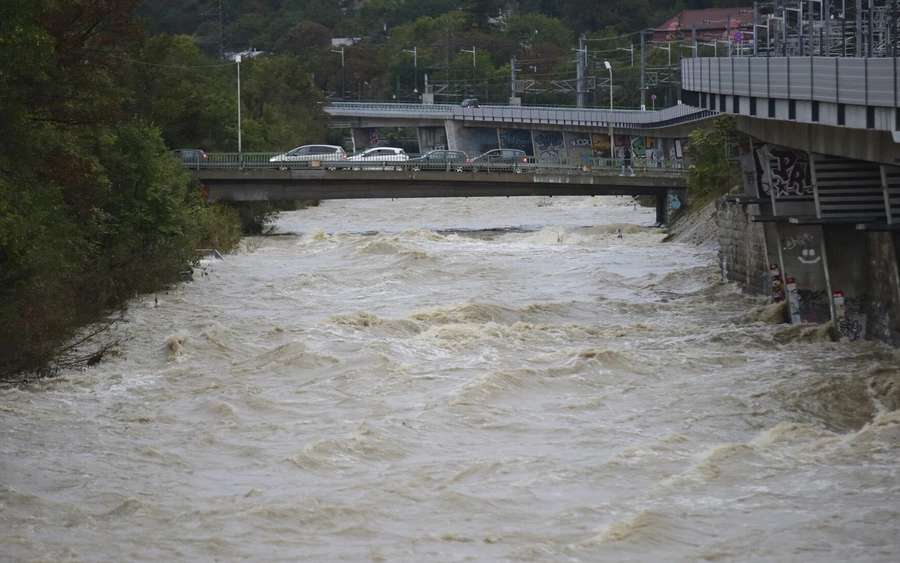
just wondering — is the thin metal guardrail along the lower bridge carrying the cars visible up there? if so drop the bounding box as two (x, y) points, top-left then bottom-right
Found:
(183, 153), (685, 177)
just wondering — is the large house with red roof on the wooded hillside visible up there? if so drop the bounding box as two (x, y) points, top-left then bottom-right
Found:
(652, 6), (753, 43)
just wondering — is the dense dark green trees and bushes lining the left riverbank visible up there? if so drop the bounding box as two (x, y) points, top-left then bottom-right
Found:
(0, 0), (250, 378)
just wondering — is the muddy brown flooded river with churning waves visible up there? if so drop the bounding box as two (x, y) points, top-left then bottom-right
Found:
(0, 198), (900, 562)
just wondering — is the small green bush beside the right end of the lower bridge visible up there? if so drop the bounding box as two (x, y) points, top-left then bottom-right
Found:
(685, 115), (741, 207)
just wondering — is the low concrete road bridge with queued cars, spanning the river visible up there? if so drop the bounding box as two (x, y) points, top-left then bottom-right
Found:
(189, 153), (685, 226)
